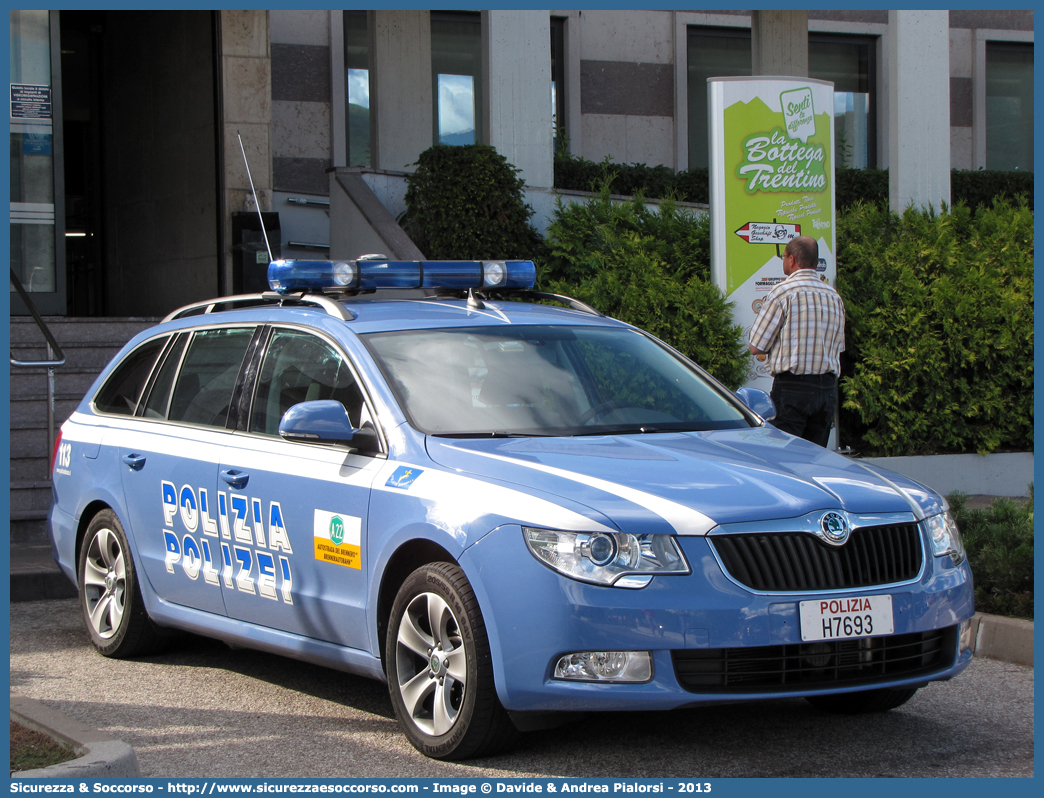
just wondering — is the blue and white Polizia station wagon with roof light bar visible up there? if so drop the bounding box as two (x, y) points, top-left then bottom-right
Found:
(50, 259), (973, 759)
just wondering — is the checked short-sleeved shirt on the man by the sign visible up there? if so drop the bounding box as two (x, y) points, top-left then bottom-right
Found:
(750, 268), (845, 375)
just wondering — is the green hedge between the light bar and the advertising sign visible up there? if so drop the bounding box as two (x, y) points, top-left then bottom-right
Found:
(538, 180), (749, 388)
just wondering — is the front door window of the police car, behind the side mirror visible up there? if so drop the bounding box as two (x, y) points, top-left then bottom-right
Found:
(250, 330), (364, 436)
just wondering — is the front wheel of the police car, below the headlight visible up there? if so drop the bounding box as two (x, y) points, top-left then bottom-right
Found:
(384, 562), (519, 759)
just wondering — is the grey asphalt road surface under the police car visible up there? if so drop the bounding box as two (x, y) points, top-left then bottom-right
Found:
(10, 600), (1034, 777)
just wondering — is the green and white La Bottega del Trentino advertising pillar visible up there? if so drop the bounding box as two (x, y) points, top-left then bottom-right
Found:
(707, 77), (836, 392)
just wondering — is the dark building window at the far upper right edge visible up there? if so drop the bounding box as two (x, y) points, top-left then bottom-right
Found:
(986, 42), (1034, 171)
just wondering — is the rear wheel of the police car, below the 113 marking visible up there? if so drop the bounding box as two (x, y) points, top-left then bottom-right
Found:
(77, 510), (161, 659)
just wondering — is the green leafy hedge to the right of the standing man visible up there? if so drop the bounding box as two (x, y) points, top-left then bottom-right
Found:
(837, 201), (1034, 455)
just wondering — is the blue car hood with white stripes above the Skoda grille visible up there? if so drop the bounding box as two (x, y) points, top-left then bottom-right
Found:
(427, 427), (943, 535)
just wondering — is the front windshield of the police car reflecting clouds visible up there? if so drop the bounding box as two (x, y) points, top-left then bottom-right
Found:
(363, 325), (751, 438)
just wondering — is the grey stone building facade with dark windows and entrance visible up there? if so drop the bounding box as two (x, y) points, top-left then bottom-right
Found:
(10, 10), (1034, 316)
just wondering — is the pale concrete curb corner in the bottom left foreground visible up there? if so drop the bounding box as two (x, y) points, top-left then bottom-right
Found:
(10, 694), (141, 778)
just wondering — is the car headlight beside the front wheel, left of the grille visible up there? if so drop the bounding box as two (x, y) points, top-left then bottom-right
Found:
(522, 526), (689, 588)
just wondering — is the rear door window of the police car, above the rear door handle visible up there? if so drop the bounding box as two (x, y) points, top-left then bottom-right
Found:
(167, 327), (255, 427)
